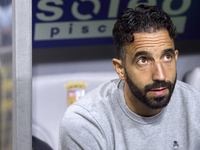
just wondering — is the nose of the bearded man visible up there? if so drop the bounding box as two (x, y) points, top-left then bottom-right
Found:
(152, 63), (166, 81)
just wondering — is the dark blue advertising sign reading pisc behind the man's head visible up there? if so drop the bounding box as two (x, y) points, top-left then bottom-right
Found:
(32, 0), (200, 48)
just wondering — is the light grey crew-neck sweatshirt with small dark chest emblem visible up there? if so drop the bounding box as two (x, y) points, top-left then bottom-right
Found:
(59, 79), (200, 150)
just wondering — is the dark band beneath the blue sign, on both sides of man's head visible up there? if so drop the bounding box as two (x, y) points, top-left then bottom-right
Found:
(32, 40), (200, 65)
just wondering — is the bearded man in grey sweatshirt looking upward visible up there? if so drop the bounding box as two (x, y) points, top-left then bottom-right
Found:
(59, 5), (200, 150)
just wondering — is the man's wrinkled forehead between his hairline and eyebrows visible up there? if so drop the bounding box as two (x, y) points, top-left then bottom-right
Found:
(126, 30), (174, 53)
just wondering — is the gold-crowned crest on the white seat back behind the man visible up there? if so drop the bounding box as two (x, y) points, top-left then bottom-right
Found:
(64, 81), (88, 106)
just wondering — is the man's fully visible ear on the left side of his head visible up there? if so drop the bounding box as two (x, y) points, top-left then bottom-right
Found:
(112, 58), (126, 80)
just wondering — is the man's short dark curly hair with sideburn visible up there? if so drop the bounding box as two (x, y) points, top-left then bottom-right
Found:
(113, 5), (176, 63)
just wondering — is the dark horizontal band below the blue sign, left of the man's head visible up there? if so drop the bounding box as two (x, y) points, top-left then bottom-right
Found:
(32, 45), (115, 65)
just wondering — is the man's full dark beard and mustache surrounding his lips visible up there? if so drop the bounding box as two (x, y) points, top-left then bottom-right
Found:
(125, 70), (177, 109)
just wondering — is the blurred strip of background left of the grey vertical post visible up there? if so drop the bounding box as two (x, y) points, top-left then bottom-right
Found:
(0, 0), (12, 150)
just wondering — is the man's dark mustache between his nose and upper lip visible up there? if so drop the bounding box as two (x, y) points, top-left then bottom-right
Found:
(144, 81), (172, 92)
